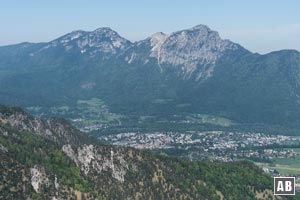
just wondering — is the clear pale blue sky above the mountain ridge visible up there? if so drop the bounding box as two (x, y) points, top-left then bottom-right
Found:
(0, 0), (300, 54)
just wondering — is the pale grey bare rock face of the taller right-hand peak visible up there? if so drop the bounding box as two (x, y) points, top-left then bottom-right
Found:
(152, 25), (240, 79)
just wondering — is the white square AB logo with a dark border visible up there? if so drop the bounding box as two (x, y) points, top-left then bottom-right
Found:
(274, 177), (295, 195)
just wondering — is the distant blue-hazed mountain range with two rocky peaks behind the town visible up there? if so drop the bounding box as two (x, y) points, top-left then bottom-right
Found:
(0, 25), (300, 134)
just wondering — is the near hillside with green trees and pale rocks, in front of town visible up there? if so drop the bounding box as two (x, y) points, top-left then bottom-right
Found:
(0, 106), (290, 200)
